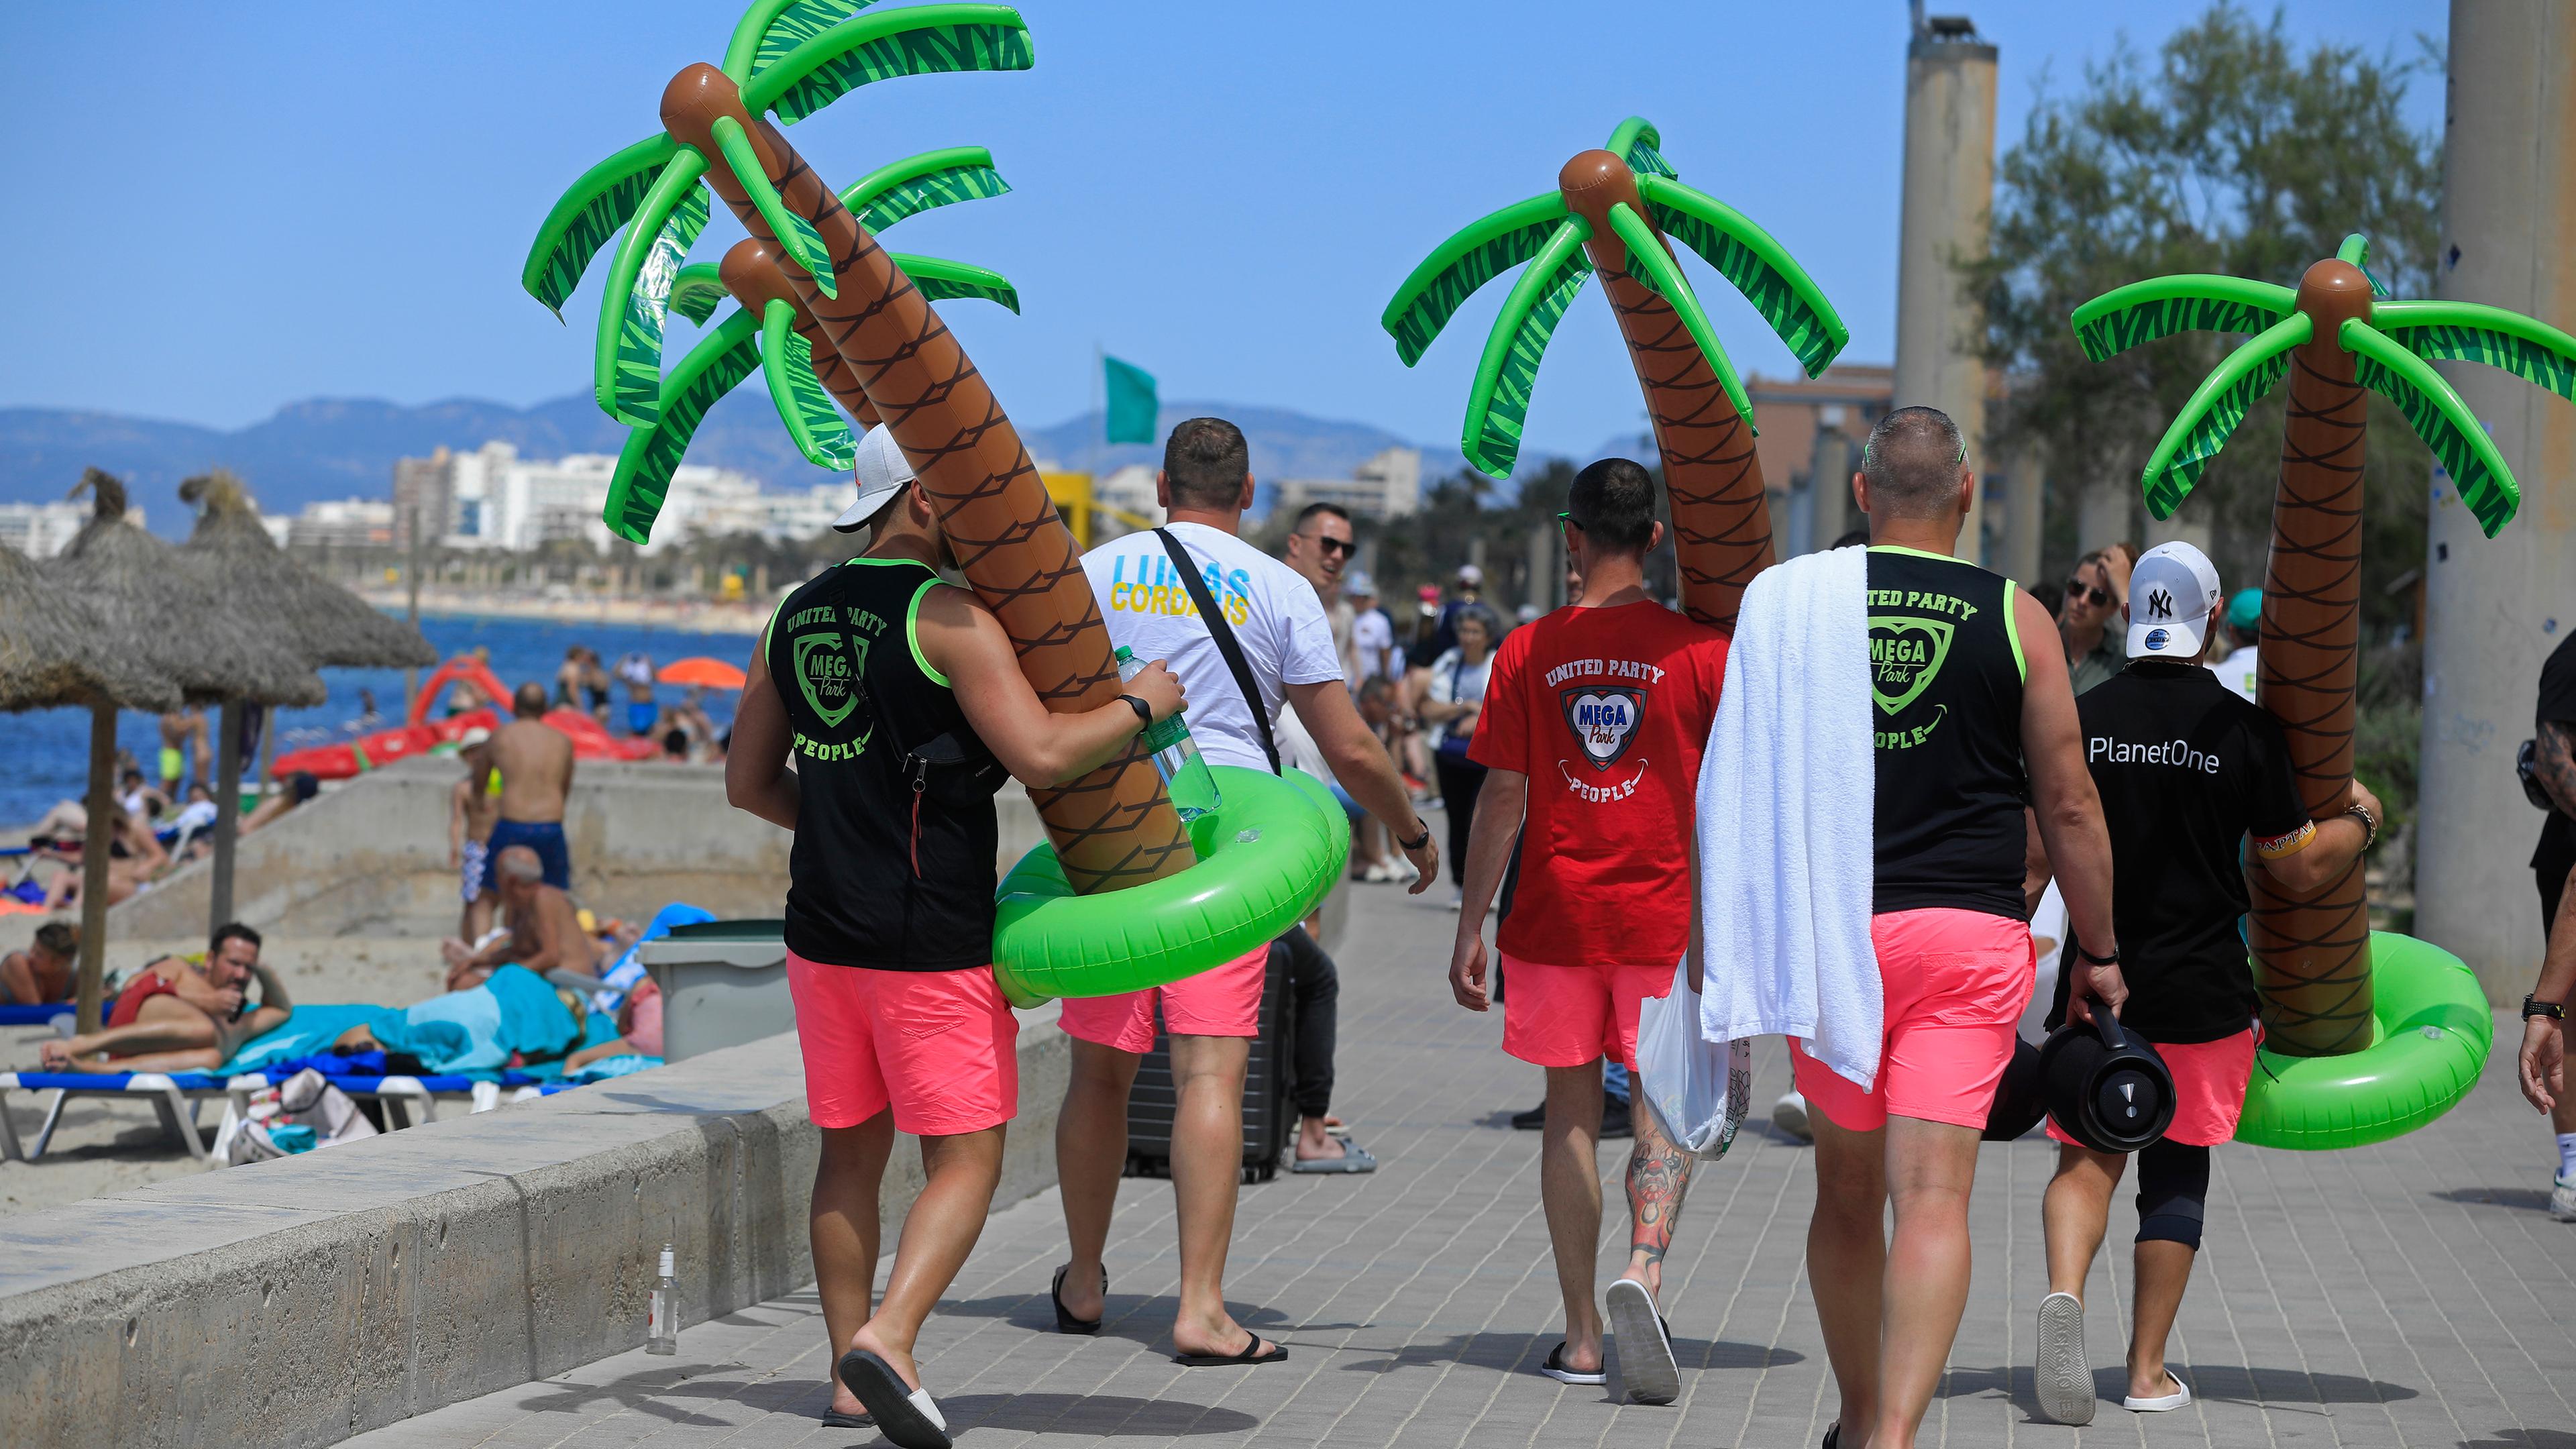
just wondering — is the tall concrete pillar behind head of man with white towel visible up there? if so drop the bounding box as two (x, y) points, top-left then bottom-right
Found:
(1885, 5), (1996, 551)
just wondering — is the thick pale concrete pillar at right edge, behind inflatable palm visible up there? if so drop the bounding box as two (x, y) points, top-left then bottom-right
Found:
(2416, 0), (2576, 1000)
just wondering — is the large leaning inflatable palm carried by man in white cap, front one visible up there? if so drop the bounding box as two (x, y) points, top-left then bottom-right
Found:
(523, 0), (1193, 895)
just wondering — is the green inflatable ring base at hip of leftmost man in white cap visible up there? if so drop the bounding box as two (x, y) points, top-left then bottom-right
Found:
(991, 765), (1350, 1008)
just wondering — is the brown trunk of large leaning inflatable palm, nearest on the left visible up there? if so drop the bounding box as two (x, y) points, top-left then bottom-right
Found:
(662, 64), (1195, 895)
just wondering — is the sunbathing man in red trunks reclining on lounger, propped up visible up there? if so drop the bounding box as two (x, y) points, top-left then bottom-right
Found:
(39, 920), (294, 1073)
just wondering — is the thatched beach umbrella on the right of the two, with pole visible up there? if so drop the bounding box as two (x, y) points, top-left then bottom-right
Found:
(178, 470), (438, 930)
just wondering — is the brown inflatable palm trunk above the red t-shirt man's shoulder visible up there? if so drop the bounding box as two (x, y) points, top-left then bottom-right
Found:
(1556, 150), (1775, 629)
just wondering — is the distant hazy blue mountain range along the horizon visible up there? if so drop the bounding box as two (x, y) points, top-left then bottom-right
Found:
(0, 387), (1463, 534)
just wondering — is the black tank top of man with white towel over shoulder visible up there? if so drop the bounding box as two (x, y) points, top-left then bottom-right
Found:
(1870, 547), (2030, 920)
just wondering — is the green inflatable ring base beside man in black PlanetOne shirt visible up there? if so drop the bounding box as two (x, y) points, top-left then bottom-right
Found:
(2236, 930), (2496, 1152)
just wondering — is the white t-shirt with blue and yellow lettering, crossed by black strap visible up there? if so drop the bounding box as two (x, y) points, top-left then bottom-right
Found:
(1082, 523), (1342, 771)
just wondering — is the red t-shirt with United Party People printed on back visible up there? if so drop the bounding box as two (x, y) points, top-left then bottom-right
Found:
(1468, 603), (1726, 967)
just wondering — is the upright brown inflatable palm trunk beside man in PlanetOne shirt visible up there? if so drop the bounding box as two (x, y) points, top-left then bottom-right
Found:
(2246, 260), (2373, 1057)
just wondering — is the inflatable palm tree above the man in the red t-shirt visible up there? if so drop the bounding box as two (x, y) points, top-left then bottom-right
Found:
(1383, 116), (1849, 627)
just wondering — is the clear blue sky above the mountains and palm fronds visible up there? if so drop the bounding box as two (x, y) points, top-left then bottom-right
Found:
(0, 0), (2445, 451)
